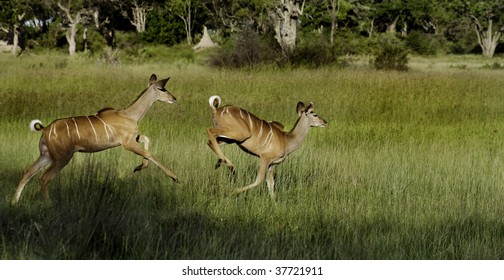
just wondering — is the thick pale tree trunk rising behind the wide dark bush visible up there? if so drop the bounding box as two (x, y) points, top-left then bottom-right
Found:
(272, 0), (305, 56)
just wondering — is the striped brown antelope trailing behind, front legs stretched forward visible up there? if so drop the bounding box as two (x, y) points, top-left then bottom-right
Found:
(12, 74), (178, 204)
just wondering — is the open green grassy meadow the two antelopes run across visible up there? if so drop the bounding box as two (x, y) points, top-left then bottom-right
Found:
(0, 55), (504, 259)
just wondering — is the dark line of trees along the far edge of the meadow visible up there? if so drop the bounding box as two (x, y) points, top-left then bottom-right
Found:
(0, 0), (504, 64)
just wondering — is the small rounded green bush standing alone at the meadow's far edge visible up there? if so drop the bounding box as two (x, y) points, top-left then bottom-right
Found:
(371, 34), (408, 71)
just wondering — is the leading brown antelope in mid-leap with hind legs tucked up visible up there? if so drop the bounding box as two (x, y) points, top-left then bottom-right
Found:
(207, 95), (327, 198)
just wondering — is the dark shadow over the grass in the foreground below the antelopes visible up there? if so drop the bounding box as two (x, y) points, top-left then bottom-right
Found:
(0, 162), (504, 259)
